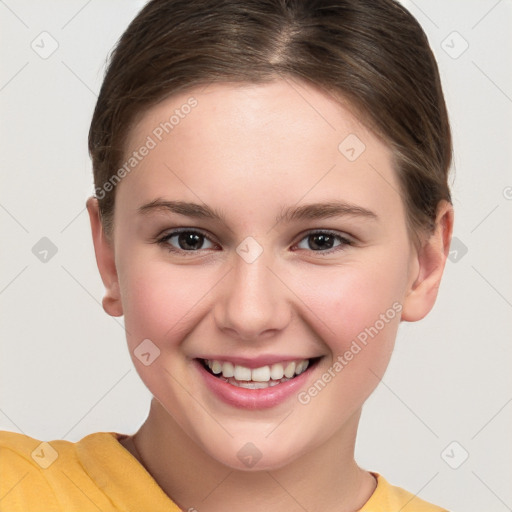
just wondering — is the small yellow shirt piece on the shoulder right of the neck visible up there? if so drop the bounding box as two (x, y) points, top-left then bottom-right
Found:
(360, 473), (448, 512)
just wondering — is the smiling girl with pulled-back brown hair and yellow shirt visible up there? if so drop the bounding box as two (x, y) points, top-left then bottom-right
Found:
(0, 0), (453, 512)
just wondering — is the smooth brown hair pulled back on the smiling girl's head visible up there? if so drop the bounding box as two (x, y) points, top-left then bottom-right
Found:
(89, 0), (452, 241)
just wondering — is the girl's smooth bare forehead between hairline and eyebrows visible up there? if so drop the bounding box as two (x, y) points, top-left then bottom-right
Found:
(119, 79), (398, 222)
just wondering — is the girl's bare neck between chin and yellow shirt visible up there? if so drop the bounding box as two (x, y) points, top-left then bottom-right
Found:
(125, 400), (376, 512)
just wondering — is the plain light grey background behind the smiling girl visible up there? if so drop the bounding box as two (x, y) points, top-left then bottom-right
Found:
(0, 0), (512, 512)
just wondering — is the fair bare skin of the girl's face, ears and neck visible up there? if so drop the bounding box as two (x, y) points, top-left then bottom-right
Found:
(87, 79), (453, 512)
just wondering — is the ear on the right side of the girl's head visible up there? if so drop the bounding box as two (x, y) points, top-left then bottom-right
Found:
(402, 200), (453, 322)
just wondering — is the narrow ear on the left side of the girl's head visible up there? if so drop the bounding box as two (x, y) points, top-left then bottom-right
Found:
(87, 197), (123, 316)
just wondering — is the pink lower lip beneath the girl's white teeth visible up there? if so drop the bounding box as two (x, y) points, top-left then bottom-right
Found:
(194, 359), (314, 409)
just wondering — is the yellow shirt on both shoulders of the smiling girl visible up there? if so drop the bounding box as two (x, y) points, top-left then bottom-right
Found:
(0, 431), (447, 512)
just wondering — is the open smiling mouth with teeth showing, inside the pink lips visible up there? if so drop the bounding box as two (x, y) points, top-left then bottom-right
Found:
(199, 357), (321, 389)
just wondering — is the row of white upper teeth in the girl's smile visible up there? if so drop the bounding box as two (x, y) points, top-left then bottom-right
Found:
(205, 359), (309, 382)
